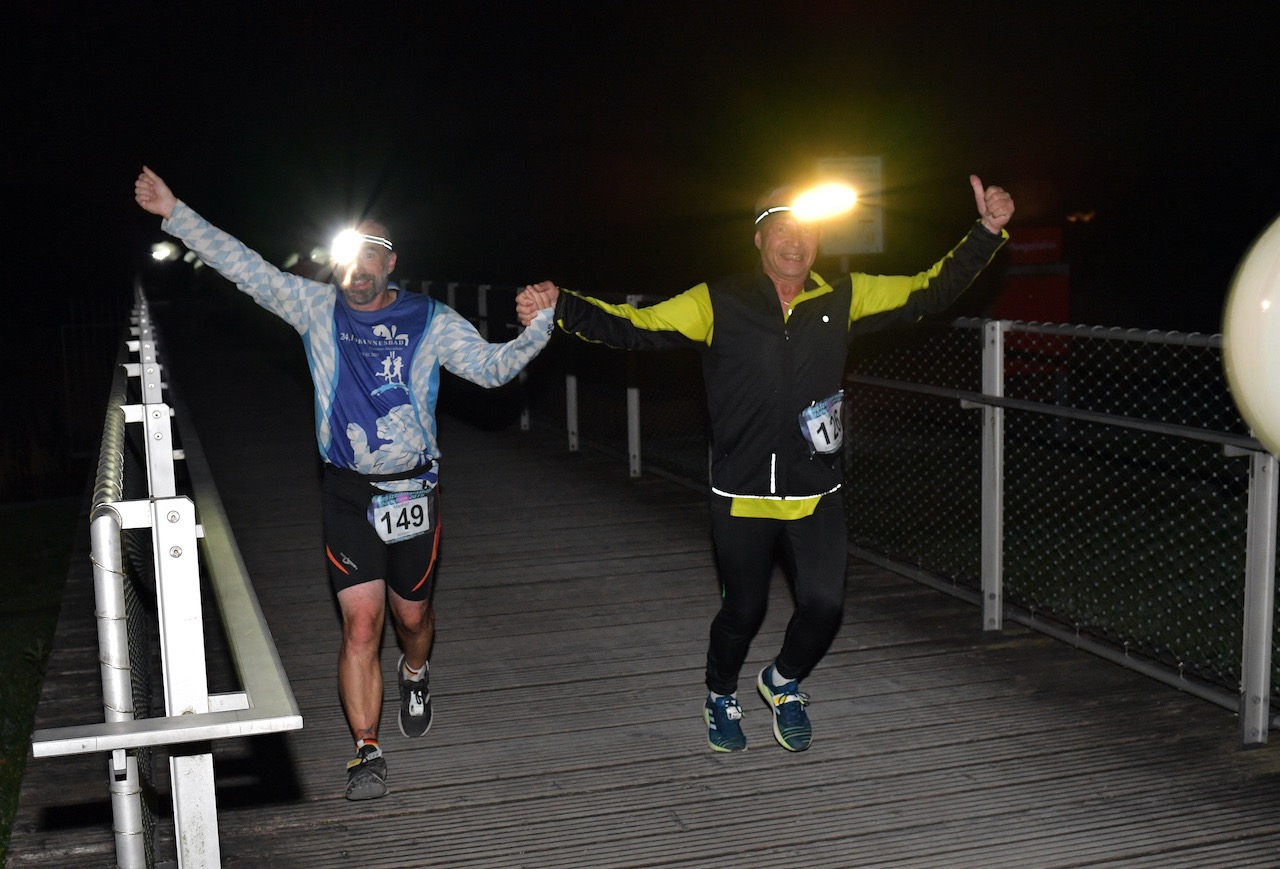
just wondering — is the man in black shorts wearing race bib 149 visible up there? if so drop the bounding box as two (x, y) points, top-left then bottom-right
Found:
(134, 166), (552, 800)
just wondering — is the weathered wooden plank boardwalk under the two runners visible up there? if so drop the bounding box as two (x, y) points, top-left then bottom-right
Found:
(8, 300), (1280, 869)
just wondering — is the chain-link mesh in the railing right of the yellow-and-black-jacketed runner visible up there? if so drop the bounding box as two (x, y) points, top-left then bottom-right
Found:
(846, 320), (1277, 691)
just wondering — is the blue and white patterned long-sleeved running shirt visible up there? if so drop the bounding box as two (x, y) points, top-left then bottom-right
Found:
(161, 202), (553, 490)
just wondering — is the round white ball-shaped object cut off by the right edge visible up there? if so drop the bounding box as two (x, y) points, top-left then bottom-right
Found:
(1222, 211), (1280, 456)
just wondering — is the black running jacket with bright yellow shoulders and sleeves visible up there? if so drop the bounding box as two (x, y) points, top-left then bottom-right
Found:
(556, 224), (1009, 517)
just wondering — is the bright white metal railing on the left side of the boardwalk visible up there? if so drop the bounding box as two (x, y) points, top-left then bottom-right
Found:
(32, 291), (302, 869)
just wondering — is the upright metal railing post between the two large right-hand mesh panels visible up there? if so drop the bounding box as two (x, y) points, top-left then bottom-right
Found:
(982, 320), (1009, 631)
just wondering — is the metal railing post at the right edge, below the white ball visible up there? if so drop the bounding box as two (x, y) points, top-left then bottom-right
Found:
(1240, 452), (1277, 746)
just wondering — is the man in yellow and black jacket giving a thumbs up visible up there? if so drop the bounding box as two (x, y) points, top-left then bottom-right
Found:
(517, 177), (1014, 751)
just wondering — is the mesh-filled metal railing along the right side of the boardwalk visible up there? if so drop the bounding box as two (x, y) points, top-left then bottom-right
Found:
(428, 284), (1280, 745)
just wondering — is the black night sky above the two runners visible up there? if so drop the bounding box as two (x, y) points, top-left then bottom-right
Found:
(0, 0), (1280, 331)
